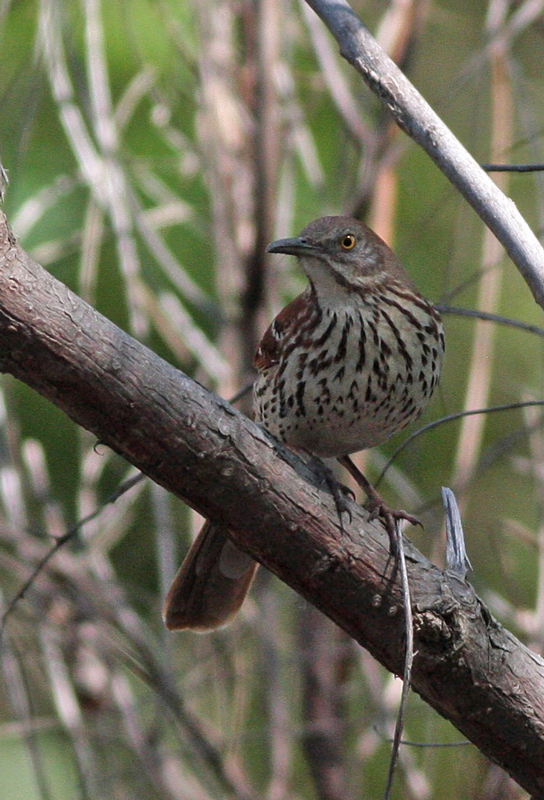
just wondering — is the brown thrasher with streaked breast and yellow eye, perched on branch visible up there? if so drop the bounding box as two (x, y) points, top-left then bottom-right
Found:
(163, 217), (444, 631)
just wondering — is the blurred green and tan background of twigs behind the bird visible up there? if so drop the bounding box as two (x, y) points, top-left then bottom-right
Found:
(0, 0), (544, 800)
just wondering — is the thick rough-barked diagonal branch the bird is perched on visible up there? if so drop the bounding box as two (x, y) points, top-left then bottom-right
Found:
(0, 213), (544, 798)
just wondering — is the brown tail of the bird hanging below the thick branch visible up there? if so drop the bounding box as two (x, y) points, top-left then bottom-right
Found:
(162, 521), (258, 633)
